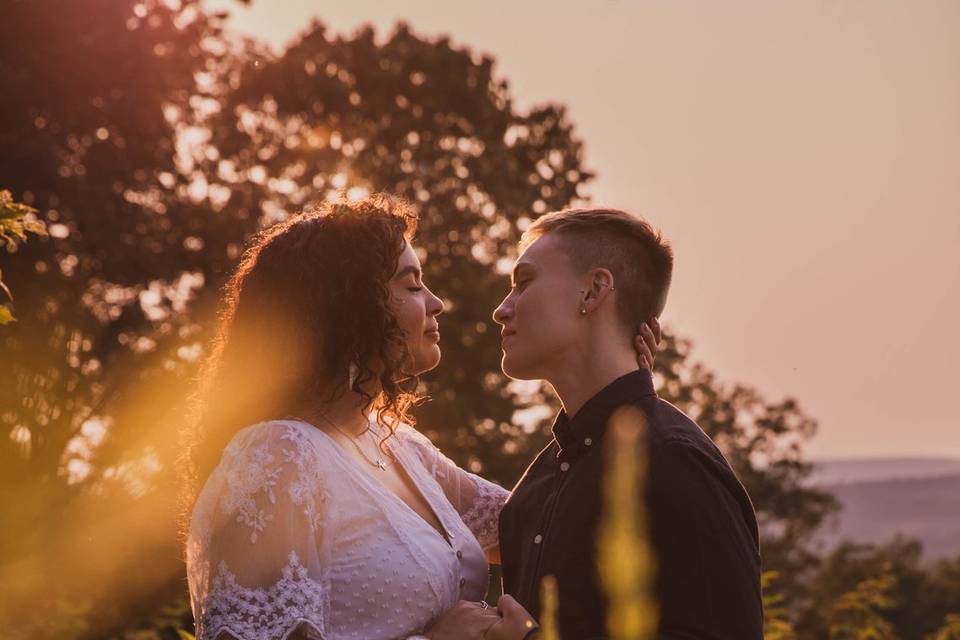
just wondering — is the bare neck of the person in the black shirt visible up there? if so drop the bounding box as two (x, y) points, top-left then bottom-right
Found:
(547, 334), (638, 418)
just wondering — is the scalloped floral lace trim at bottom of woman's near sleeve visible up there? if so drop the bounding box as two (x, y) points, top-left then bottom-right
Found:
(197, 551), (326, 640)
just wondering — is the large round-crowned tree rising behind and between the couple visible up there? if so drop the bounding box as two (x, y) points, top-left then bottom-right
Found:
(189, 17), (590, 481)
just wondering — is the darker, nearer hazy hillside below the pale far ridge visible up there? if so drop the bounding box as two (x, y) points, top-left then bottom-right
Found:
(819, 472), (960, 558)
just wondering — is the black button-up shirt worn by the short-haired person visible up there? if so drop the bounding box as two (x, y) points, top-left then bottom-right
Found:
(500, 371), (763, 640)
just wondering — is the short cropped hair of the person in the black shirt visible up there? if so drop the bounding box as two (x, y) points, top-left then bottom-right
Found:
(520, 208), (673, 328)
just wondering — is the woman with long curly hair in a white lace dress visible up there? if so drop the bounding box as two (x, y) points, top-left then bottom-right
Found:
(184, 196), (649, 640)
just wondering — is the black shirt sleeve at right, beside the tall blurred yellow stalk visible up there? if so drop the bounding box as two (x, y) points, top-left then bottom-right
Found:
(649, 442), (763, 640)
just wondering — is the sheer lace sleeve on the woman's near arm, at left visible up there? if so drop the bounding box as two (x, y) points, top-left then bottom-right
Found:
(187, 423), (329, 640)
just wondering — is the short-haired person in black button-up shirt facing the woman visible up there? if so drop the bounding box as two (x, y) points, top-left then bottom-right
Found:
(487, 209), (763, 640)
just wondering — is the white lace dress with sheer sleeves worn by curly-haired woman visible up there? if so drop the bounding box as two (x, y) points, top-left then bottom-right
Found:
(186, 420), (507, 640)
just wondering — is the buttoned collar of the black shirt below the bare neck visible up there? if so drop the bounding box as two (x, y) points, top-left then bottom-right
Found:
(553, 369), (656, 457)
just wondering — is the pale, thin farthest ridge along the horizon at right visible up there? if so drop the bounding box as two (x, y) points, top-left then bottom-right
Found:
(810, 458), (960, 486)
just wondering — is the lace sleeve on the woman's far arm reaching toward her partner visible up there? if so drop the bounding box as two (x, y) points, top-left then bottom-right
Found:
(403, 427), (510, 551)
